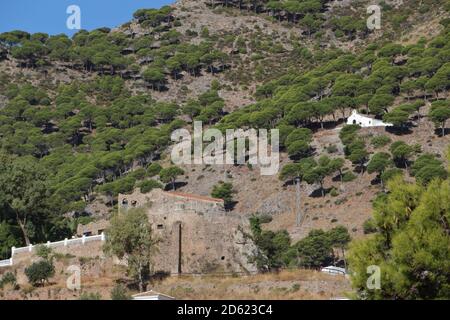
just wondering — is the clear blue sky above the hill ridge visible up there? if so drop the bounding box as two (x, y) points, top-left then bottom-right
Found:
(0, 0), (174, 35)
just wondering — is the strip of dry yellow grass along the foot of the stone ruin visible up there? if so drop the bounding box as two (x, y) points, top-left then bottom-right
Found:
(152, 270), (351, 300)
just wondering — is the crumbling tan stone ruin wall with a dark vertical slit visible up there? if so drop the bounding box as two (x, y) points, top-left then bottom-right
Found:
(119, 189), (256, 274)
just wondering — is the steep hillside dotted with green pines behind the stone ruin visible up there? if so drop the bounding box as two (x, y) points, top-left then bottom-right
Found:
(0, 0), (450, 296)
